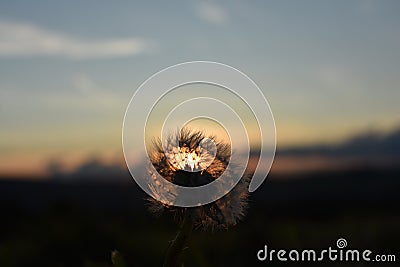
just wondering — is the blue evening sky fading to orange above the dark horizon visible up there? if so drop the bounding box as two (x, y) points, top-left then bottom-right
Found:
(0, 0), (400, 175)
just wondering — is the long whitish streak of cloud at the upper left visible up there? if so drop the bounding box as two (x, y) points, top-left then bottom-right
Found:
(0, 21), (153, 59)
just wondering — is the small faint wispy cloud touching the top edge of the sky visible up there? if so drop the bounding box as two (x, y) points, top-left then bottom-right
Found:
(195, 2), (229, 25)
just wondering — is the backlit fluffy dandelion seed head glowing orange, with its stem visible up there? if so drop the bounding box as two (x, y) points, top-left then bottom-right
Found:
(148, 128), (250, 266)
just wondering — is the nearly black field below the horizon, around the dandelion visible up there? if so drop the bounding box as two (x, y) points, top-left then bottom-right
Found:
(0, 169), (400, 267)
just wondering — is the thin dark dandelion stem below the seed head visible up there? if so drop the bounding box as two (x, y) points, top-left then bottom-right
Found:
(164, 209), (193, 267)
